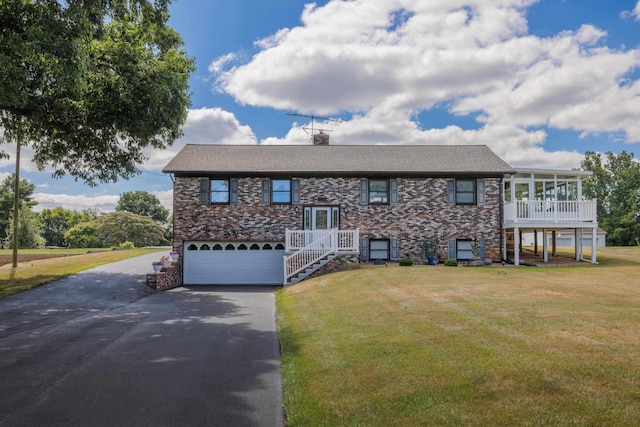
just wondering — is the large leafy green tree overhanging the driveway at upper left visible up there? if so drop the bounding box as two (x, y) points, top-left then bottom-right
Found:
(0, 0), (194, 185)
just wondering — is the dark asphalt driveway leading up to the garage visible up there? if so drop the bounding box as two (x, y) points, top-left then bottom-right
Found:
(0, 254), (284, 426)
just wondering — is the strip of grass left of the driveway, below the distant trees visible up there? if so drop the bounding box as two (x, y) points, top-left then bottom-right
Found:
(0, 248), (168, 298)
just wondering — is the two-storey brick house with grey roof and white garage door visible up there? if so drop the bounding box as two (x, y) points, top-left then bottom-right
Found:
(164, 144), (516, 285)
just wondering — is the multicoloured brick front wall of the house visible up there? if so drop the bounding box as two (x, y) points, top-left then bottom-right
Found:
(174, 176), (501, 260)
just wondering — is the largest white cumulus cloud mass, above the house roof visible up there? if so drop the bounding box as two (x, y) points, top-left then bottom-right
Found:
(216, 0), (640, 171)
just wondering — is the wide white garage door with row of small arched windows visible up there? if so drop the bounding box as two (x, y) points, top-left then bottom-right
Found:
(183, 242), (284, 285)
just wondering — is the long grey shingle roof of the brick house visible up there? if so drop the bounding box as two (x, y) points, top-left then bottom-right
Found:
(163, 144), (513, 176)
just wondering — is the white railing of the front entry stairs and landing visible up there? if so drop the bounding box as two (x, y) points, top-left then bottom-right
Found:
(284, 229), (360, 284)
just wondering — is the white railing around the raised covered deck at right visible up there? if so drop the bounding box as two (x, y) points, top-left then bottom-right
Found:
(504, 200), (597, 223)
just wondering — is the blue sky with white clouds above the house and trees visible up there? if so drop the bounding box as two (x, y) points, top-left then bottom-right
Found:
(0, 0), (640, 211)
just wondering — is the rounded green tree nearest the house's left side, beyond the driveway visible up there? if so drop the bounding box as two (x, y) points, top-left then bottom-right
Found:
(96, 211), (164, 247)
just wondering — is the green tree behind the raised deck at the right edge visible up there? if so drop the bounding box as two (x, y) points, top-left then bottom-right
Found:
(581, 151), (640, 246)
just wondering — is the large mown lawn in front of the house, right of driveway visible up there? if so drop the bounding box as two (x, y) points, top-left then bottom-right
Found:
(277, 248), (640, 426)
